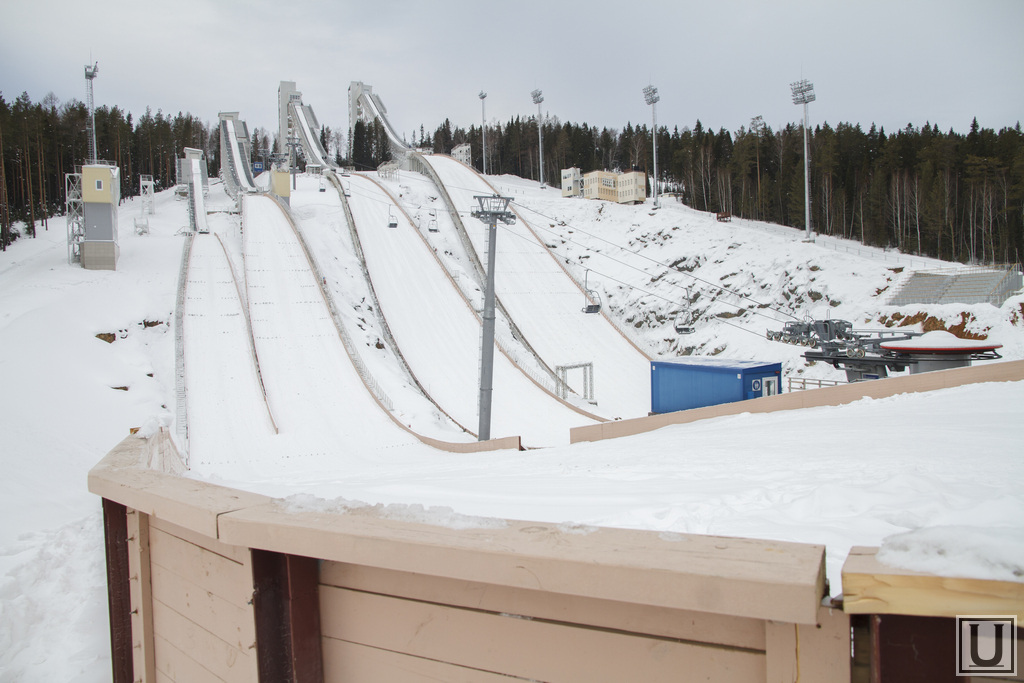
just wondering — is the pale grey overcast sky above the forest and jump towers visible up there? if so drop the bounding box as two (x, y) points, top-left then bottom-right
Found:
(0, 0), (1024, 147)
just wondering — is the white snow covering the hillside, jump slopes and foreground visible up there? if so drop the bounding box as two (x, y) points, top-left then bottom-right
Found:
(0, 167), (1024, 683)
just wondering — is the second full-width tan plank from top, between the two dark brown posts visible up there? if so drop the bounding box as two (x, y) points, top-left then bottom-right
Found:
(153, 565), (256, 651)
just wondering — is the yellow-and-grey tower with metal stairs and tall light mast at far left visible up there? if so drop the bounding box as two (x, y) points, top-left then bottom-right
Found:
(65, 63), (121, 270)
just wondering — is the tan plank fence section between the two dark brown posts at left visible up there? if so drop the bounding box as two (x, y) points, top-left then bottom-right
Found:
(142, 513), (257, 683)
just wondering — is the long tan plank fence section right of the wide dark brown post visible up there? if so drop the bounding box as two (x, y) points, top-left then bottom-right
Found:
(319, 561), (850, 683)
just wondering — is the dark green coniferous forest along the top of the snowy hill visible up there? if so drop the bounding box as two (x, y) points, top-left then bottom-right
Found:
(0, 86), (1024, 263)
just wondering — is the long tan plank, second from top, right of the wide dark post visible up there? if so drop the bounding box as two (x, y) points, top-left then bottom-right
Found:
(321, 587), (765, 683)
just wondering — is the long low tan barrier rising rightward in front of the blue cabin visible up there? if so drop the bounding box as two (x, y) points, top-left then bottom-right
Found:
(569, 360), (1024, 443)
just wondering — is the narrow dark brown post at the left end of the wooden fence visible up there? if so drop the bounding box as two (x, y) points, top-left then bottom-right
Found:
(103, 498), (134, 683)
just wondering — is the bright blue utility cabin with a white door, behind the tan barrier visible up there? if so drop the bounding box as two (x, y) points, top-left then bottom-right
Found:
(650, 357), (782, 415)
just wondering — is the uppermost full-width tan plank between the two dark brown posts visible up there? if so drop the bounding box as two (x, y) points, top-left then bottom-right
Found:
(150, 528), (253, 606)
